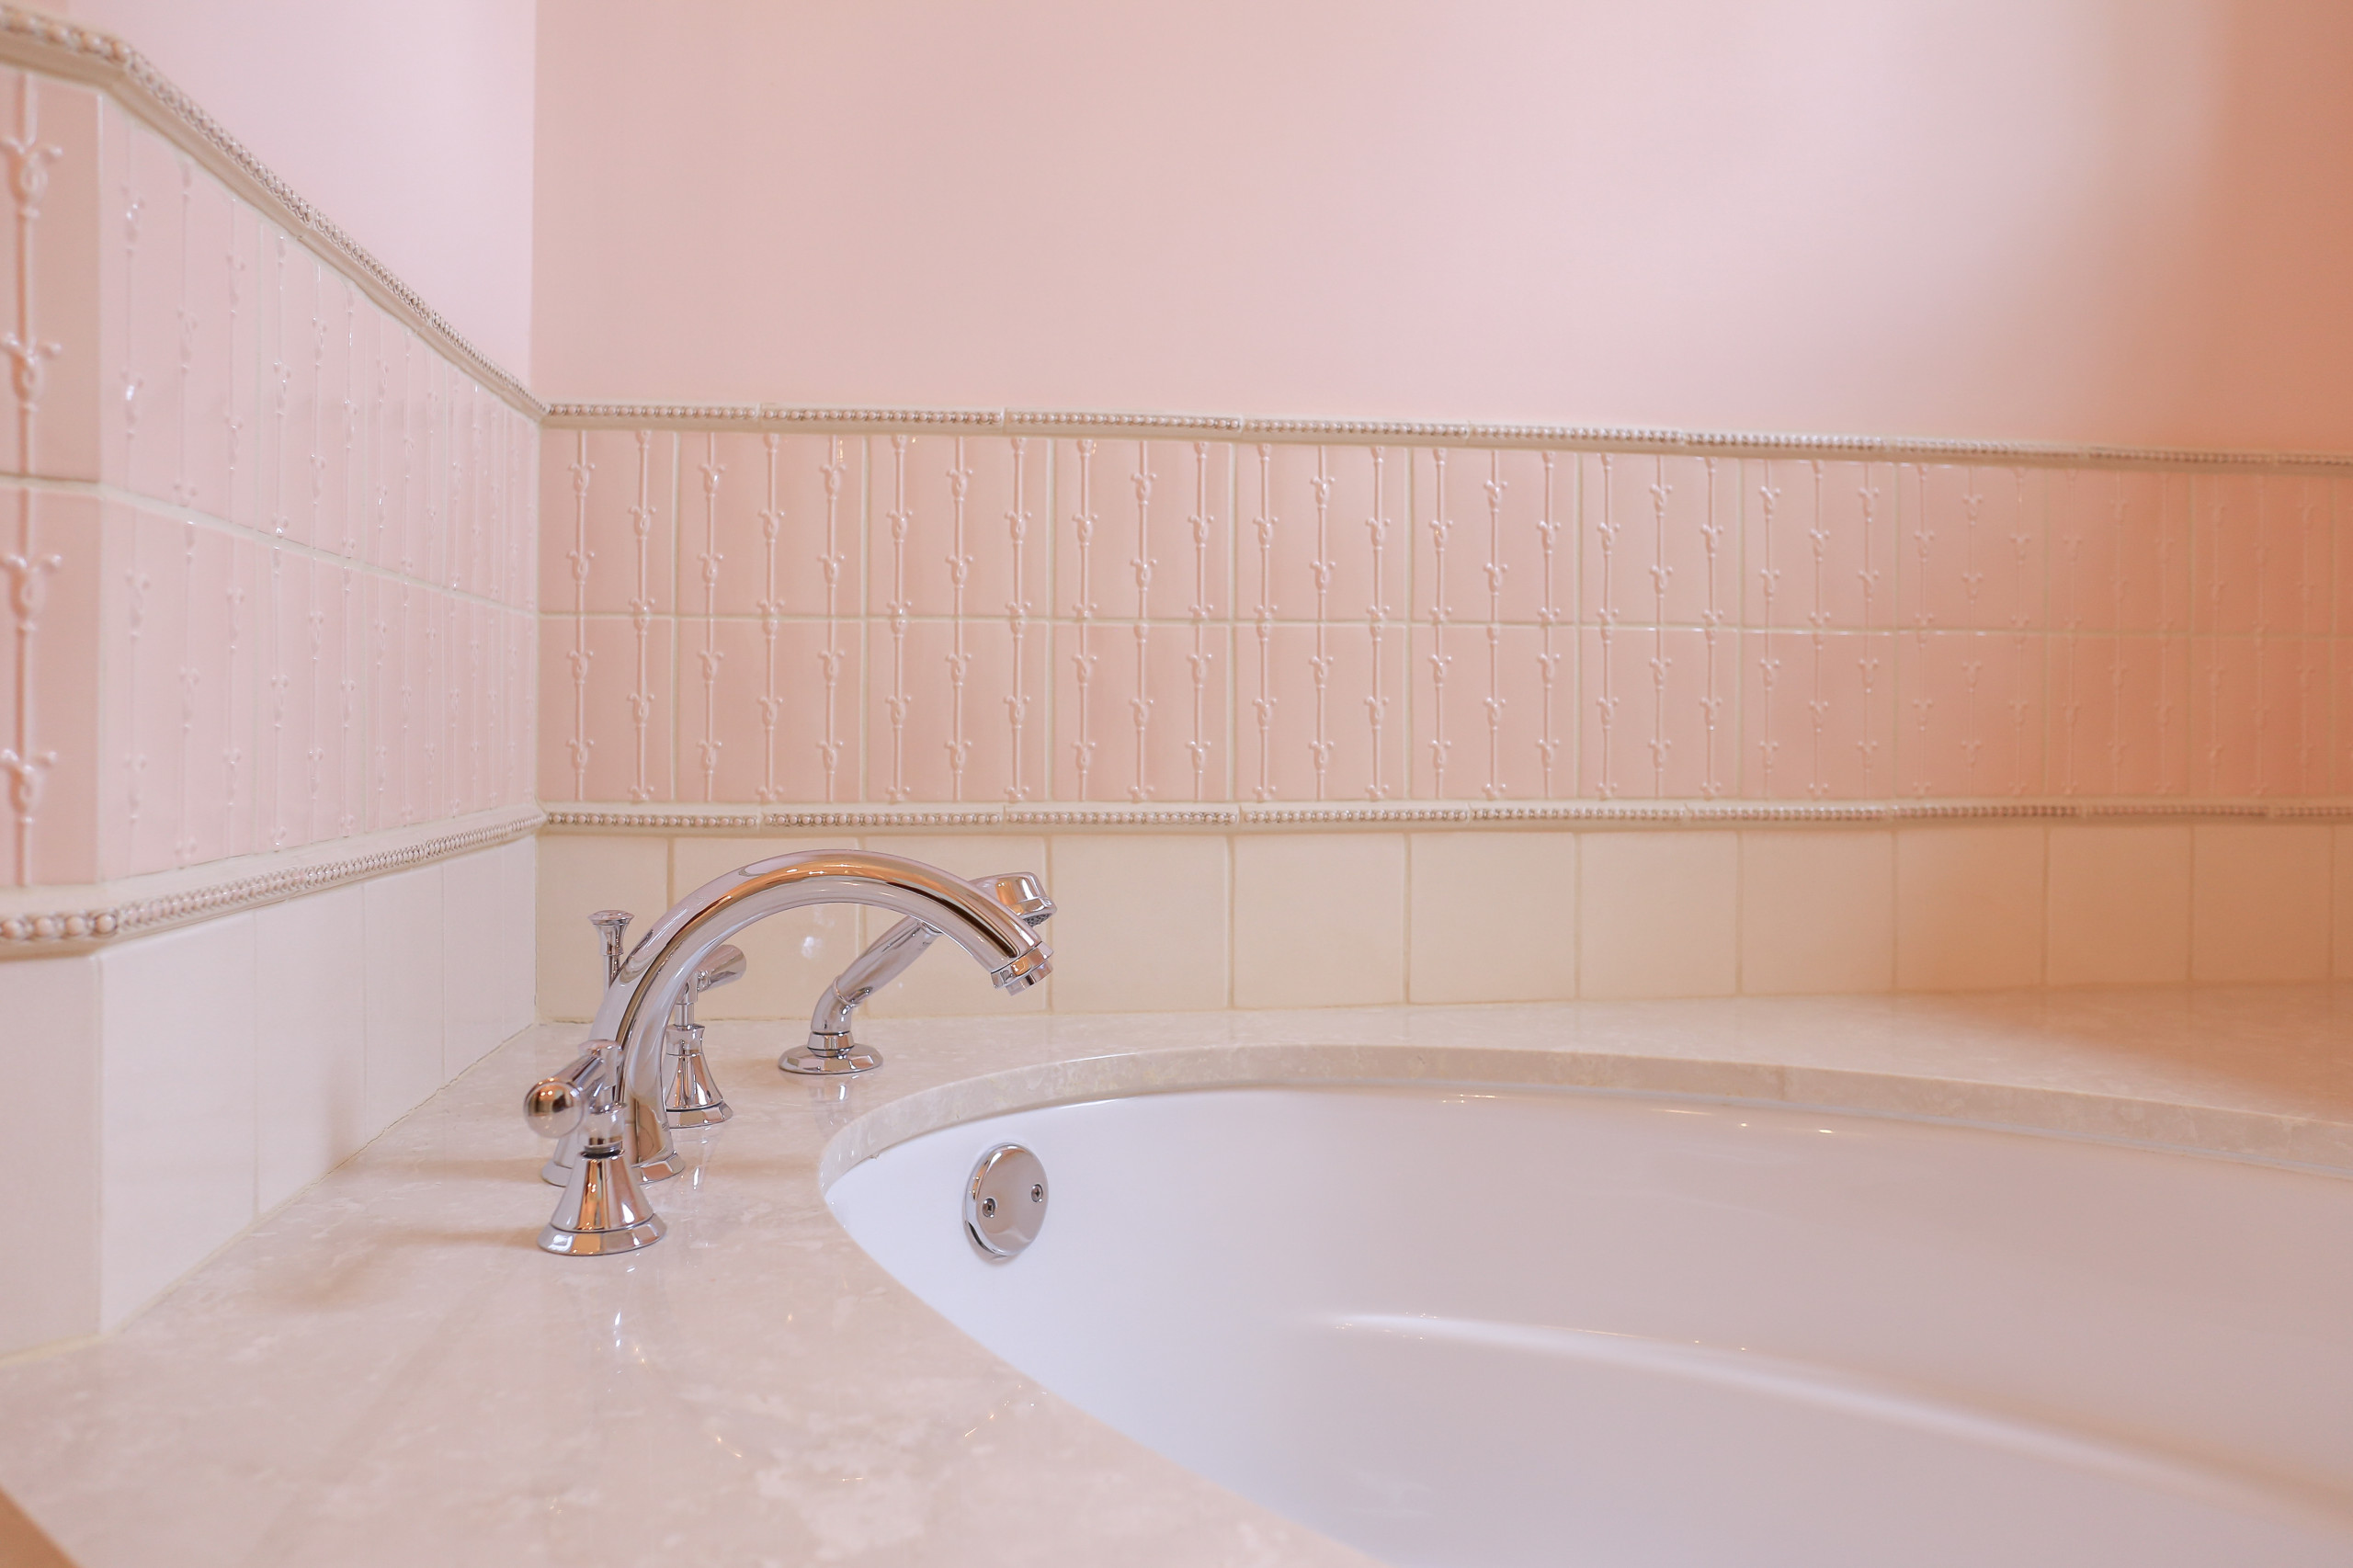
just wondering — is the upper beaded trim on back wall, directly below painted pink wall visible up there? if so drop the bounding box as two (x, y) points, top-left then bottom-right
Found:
(543, 403), (2353, 473)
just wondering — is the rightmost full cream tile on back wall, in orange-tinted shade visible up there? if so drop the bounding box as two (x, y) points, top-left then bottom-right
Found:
(2190, 822), (2332, 982)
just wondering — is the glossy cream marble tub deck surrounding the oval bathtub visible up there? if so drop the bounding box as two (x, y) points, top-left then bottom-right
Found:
(0, 986), (2353, 1568)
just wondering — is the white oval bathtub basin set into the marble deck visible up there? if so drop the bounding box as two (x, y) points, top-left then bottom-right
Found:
(828, 1087), (2353, 1568)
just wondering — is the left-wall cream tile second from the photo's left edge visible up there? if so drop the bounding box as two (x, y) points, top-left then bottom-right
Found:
(99, 914), (256, 1328)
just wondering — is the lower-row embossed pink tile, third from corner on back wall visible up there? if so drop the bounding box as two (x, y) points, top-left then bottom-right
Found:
(866, 621), (1050, 801)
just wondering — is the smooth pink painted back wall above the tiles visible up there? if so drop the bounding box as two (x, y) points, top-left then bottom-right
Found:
(539, 0), (2353, 448)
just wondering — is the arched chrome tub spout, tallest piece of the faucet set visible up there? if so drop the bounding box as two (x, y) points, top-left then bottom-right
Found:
(546, 850), (1051, 1182)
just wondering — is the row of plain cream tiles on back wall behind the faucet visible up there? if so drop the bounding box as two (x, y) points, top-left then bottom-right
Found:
(537, 814), (2353, 1021)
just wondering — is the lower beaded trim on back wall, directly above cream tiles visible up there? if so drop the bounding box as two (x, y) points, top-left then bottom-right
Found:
(546, 798), (2353, 834)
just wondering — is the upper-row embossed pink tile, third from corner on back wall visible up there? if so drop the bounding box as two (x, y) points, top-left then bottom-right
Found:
(866, 436), (1050, 617)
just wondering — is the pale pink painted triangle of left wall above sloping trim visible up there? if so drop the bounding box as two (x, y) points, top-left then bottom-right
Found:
(71, 0), (534, 377)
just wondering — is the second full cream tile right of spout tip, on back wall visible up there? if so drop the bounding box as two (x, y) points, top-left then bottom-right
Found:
(1233, 834), (1404, 1007)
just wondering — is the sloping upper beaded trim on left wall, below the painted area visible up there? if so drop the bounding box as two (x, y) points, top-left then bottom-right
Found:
(0, 5), (546, 419)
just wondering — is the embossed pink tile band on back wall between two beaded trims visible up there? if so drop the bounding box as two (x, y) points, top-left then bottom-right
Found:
(537, 428), (2353, 802)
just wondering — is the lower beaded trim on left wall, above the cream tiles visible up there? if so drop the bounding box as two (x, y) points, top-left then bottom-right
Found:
(0, 805), (543, 960)
